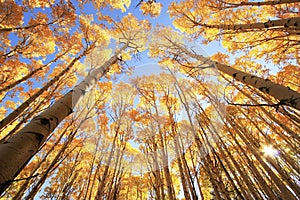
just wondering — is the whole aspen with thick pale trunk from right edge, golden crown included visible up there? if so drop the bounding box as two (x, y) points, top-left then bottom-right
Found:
(150, 28), (300, 110)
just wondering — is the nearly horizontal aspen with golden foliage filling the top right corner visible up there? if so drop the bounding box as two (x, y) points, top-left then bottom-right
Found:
(169, 0), (300, 64)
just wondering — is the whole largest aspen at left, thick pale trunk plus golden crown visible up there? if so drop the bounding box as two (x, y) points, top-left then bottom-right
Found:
(0, 11), (150, 193)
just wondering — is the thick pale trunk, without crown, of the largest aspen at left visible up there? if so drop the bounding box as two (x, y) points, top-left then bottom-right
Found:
(0, 43), (128, 194)
